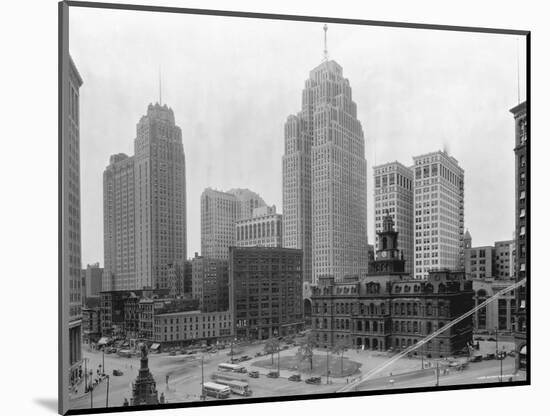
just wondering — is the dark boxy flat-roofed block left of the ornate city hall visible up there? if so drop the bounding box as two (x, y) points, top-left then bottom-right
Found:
(229, 247), (304, 339)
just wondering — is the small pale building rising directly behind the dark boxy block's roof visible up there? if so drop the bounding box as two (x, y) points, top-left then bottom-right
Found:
(235, 205), (283, 247)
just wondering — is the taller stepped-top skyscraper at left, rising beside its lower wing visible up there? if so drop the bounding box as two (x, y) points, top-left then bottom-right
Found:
(134, 104), (187, 289)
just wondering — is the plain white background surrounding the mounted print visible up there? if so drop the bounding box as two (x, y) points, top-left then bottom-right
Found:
(0, 0), (550, 416)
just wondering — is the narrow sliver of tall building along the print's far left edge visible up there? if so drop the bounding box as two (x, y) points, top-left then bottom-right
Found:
(61, 56), (82, 386)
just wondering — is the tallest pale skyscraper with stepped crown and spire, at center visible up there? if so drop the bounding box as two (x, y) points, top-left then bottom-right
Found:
(283, 26), (368, 283)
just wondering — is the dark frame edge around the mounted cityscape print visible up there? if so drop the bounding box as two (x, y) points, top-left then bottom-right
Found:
(58, 1), (531, 415)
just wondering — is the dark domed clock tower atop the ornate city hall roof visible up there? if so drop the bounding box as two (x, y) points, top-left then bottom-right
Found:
(372, 211), (405, 273)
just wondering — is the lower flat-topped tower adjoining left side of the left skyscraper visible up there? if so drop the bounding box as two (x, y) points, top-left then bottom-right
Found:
(102, 153), (137, 290)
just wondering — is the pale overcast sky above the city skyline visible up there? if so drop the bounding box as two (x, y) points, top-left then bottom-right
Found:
(69, 7), (525, 266)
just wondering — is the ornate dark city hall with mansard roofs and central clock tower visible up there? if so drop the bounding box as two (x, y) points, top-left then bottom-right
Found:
(312, 216), (473, 357)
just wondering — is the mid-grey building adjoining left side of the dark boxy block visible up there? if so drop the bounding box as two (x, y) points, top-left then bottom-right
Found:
(191, 254), (229, 312)
